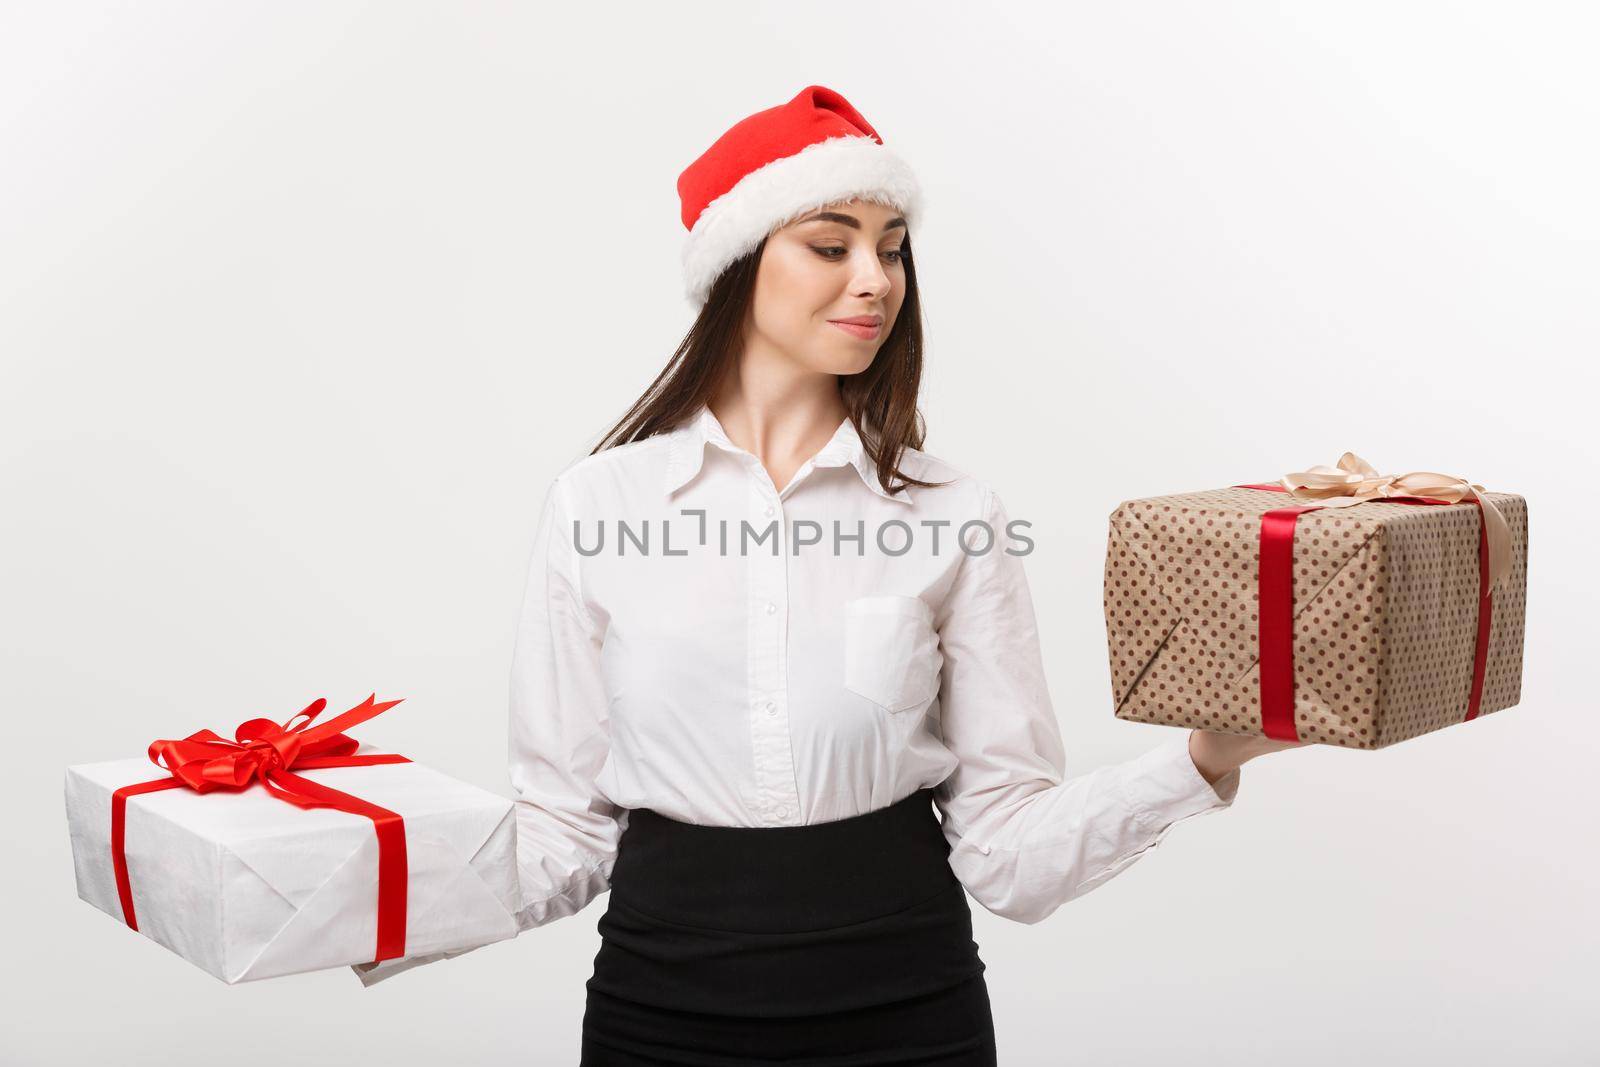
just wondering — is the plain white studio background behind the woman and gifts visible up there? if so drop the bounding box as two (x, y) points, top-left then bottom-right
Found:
(0, 0), (1600, 1067)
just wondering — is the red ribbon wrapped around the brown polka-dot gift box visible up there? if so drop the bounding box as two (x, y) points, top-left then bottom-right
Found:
(1232, 483), (1494, 741)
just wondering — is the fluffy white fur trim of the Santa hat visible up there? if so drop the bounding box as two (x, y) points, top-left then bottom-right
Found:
(683, 138), (922, 307)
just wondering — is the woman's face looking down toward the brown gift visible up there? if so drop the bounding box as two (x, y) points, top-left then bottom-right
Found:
(746, 200), (906, 374)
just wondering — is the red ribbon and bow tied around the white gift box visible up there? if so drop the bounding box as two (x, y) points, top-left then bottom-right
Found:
(110, 693), (411, 963)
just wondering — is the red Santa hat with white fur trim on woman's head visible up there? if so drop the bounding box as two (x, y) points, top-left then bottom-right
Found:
(678, 85), (922, 307)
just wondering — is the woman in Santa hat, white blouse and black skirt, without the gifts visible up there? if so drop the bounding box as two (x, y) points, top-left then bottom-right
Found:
(360, 85), (1286, 1067)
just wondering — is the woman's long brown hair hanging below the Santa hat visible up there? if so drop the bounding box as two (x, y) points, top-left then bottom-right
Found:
(590, 234), (944, 493)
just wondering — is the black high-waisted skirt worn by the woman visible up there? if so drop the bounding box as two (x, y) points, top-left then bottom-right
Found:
(581, 789), (995, 1067)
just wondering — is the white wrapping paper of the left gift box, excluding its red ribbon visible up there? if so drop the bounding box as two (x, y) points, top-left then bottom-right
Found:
(66, 745), (518, 984)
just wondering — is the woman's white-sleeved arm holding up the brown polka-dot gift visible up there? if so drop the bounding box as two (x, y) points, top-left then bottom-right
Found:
(934, 490), (1238, 923)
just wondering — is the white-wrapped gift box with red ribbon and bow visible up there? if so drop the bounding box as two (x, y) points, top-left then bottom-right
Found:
(66, 697), (518, 984)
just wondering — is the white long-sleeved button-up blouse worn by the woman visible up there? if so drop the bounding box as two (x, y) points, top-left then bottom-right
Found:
(358, 406), (1238, 984)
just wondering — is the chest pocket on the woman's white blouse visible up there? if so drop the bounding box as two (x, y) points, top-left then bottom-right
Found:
(845, 595), (944, 712)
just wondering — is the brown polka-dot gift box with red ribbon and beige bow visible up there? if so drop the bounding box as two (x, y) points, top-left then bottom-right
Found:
(1104, 453), (1528, 749)
